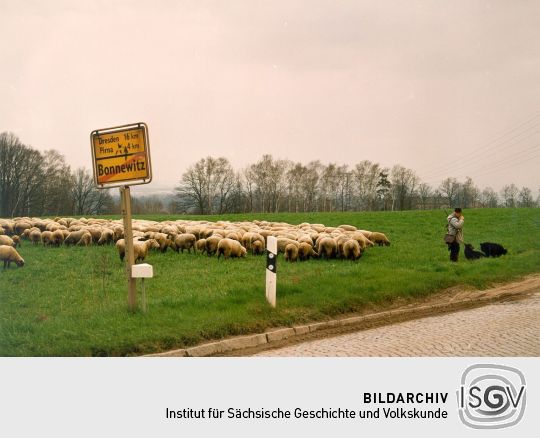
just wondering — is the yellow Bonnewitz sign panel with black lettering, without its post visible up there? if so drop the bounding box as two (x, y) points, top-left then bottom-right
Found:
(90, 123), (152, 188)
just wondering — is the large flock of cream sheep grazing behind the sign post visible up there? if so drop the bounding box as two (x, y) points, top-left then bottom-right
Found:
(0, 217), (390, 268)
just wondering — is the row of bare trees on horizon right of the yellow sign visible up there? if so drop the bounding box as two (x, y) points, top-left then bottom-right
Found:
(172, 155), (538, 214)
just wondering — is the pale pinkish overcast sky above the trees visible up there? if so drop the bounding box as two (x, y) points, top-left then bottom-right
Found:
(0, 0), (540, 193)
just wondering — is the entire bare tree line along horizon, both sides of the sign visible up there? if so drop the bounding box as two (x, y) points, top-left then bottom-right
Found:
(0, 132), (540, 217)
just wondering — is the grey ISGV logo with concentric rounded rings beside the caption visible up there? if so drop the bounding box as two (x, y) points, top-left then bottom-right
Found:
(457, 364), (527, 429)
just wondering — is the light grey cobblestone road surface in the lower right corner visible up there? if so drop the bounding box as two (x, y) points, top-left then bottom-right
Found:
(255, 293), (540, 356)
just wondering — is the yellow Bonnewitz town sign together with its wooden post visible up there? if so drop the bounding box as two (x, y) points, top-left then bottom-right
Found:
(90, 122), (152, 312)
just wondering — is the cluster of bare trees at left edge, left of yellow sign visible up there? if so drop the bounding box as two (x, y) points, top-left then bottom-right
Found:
(0, 132), (115, 217)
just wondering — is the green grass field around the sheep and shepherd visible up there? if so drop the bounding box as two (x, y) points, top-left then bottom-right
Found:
(0, 209), (540, 356)
